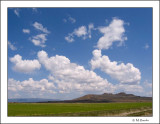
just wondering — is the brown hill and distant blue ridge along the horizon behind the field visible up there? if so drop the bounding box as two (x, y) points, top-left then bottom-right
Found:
(8, 92), (152, 103)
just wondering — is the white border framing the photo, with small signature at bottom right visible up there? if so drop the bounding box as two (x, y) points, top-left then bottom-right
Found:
(1, 1), (159, 123)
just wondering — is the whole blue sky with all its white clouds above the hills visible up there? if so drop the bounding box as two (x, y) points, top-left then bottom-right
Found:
(8, 8), (153, 100)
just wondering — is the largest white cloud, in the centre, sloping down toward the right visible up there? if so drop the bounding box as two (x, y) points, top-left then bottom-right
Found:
(38, 51), (114, 93)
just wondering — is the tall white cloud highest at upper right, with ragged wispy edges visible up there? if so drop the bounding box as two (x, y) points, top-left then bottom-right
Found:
(97, 18), (127, 49)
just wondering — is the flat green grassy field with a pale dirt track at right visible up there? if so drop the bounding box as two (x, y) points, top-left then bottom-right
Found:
(8, 102), (152, 116)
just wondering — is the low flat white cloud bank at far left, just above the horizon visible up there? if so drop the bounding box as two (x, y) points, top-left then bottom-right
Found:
(8, 78), (56, 98)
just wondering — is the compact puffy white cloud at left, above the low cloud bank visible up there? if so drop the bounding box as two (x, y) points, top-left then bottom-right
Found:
(10, 54), (41, 73)
